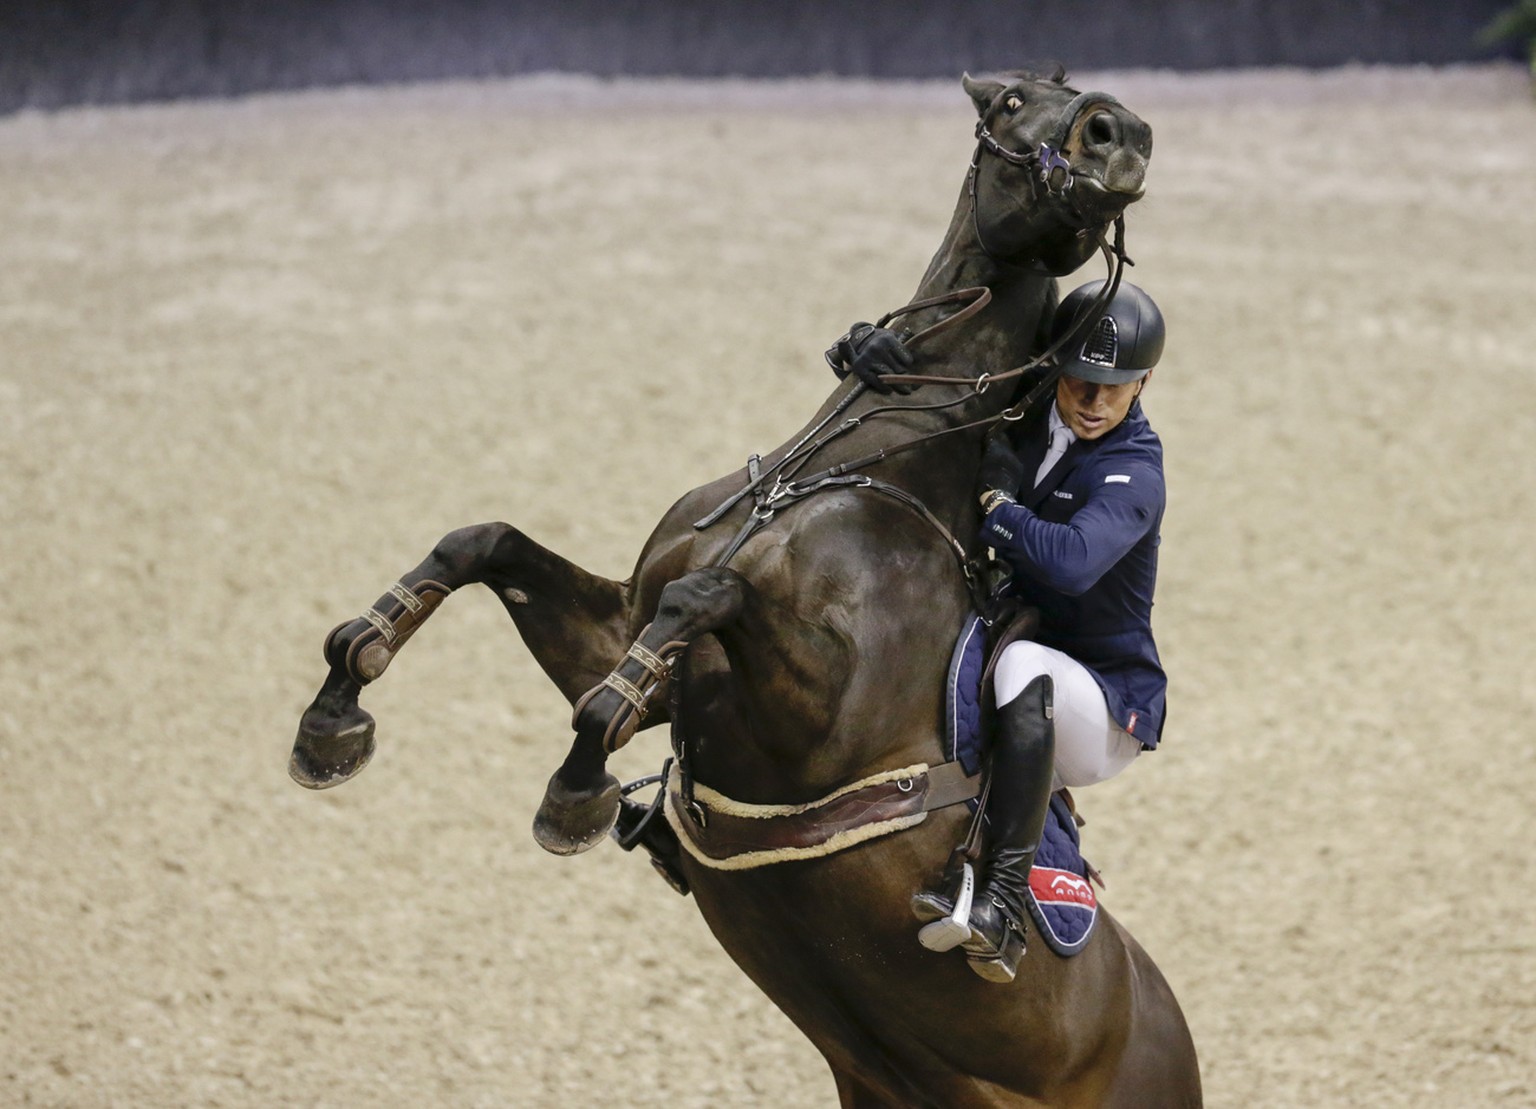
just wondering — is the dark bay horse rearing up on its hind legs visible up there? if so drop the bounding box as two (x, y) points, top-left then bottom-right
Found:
(290, 72), (1200, 1106)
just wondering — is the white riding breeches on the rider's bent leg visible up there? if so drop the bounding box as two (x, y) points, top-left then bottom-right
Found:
(992, 641), (1141, 790)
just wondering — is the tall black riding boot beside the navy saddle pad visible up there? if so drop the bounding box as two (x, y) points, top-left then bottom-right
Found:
(912, 674), (1055, 982)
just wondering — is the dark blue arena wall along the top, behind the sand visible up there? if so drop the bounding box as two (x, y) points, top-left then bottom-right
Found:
(0, 0), (1518, 112)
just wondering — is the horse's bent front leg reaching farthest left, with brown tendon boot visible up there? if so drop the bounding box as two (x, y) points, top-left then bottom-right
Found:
(289, 524), (628, 790)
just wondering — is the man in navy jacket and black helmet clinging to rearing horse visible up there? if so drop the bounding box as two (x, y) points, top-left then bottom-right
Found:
(828, 281), (1167, 982)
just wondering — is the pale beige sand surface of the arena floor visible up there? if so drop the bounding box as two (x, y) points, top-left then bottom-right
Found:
(0, 68), (1536, 1106)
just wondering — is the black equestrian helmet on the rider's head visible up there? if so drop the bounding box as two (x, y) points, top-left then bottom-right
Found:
(1051, 281), (1164, 386)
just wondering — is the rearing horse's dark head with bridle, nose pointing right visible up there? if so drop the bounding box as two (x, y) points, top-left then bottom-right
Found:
(963, 71), (1152, 275)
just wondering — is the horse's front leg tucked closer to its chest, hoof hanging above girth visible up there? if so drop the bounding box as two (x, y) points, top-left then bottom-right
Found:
(533, 567), (751, 856)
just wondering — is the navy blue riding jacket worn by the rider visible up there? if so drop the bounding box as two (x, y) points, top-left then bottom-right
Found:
(982, 401), (1167, 748)
